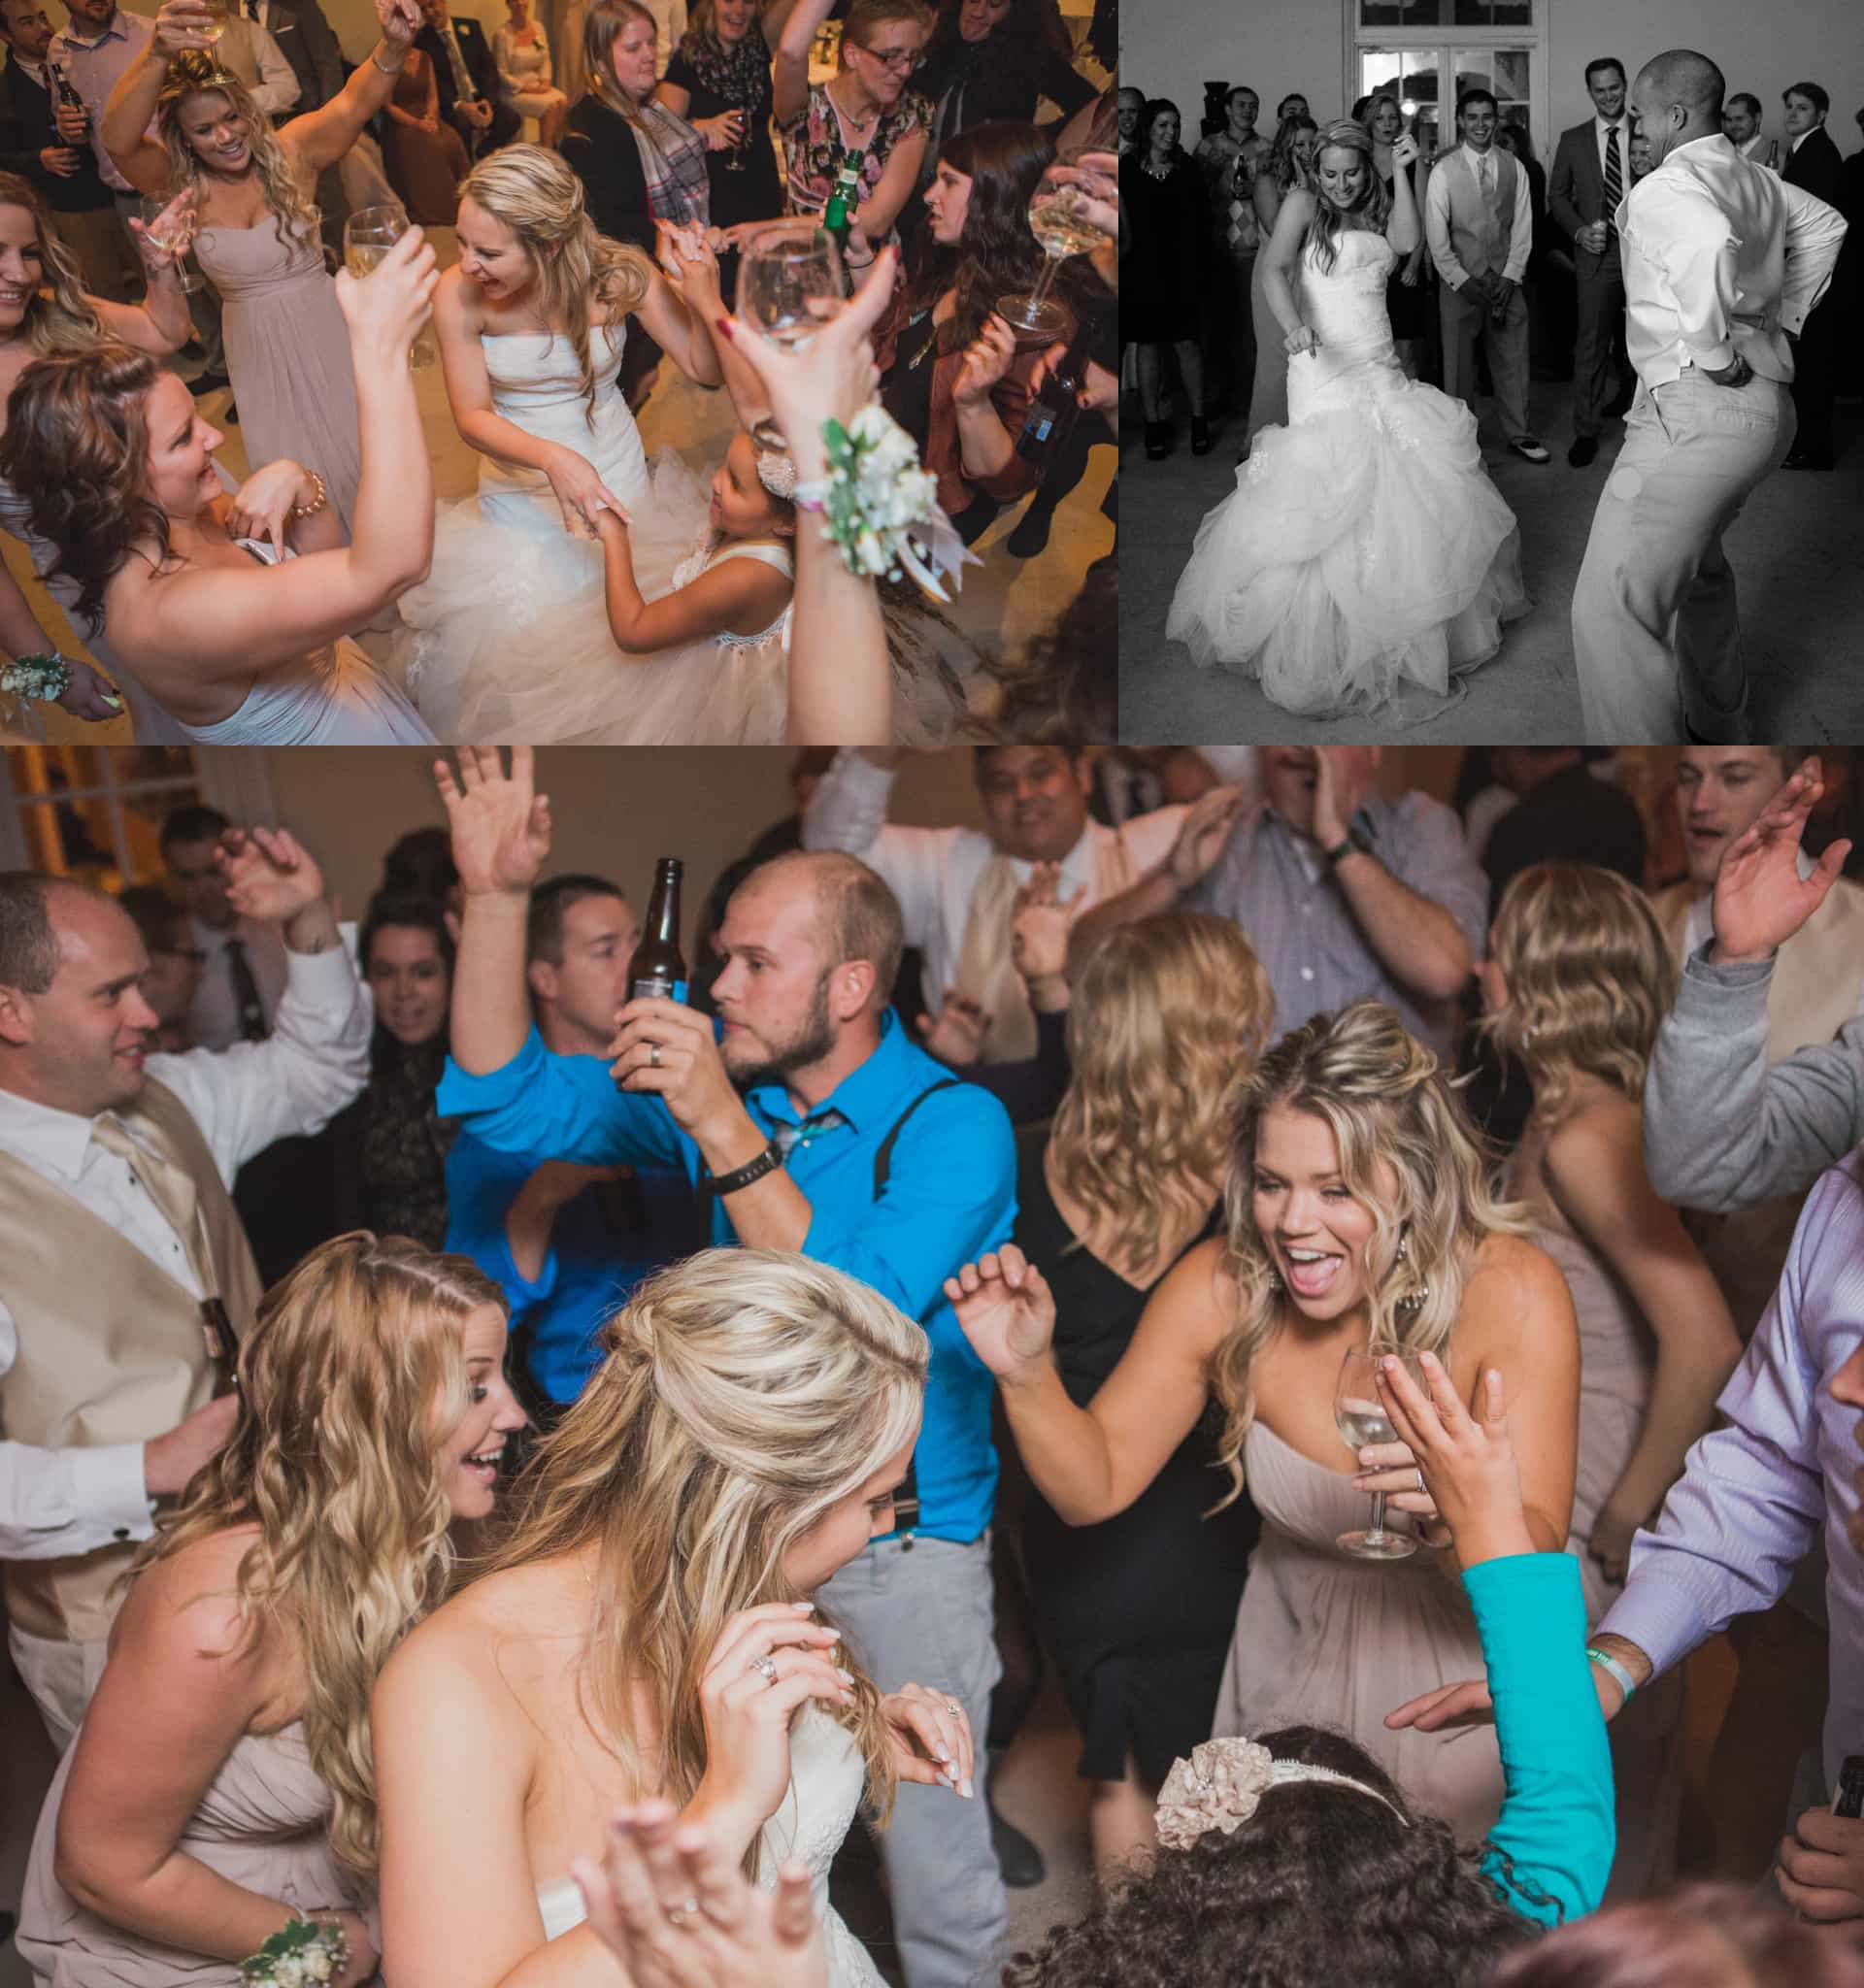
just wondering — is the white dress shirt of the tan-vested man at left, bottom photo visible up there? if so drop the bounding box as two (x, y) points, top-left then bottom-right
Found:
(0, 946), (374, 1561)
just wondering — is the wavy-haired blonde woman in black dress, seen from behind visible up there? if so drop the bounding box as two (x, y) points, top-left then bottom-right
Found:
(1015, 912), (1274, 1878)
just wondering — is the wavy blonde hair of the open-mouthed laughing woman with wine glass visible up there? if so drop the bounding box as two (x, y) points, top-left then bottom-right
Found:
(1213, 1000), (1532, 1503)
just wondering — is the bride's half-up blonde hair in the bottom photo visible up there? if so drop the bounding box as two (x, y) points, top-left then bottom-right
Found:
(473, 1248), (930, 1872)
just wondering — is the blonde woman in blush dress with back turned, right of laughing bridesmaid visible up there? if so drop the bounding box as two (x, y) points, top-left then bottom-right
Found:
(1479, 863), (1741, 1899)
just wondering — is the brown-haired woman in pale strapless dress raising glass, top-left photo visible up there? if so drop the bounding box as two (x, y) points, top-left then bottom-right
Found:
(0, 229), (433, 746)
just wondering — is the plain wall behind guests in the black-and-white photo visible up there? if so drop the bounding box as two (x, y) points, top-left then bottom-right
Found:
(1118, 0), (1864, 153)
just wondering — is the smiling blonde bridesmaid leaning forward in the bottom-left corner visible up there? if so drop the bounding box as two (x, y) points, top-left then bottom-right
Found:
(17, 1235), (524, 1988)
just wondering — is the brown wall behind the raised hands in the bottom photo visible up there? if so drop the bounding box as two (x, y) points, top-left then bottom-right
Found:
(266, 746), (980, 954)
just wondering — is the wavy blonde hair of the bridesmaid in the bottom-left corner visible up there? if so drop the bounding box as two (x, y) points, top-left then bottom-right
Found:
(129, 1231), (505, 1876)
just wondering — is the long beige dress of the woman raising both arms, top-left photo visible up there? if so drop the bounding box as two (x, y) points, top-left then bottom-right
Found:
(195, 215), (362, 535)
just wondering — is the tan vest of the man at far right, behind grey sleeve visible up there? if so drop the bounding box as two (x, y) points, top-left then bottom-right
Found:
(1651, 877), (1864, 1340)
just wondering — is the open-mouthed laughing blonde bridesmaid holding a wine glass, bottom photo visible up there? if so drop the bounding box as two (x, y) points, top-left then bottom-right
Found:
(946, 1002), (1580, 1840)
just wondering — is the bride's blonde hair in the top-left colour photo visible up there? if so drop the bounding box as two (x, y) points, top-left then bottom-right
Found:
(459, 146), (653, 429)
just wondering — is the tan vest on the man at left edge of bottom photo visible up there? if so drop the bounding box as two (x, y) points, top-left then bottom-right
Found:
(0, 1079), (258, 1642)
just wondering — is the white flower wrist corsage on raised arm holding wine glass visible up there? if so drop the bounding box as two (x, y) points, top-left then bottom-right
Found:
(795, 404), (982, 600)
